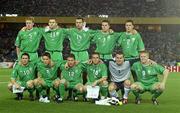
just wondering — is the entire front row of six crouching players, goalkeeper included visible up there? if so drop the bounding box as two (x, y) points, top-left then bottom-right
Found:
(8, 51), (168, 105)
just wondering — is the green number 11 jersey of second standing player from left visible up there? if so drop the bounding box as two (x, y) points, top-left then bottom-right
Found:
(42, 28), (65, 51)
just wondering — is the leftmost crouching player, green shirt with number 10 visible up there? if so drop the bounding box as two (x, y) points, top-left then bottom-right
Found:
(8, 53), (35, 100)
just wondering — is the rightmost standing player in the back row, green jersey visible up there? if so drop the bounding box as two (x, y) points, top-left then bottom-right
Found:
(118, 20), (145, 81)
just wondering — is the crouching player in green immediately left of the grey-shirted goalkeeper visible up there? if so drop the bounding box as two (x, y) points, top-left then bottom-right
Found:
(84, 52), (108, 99)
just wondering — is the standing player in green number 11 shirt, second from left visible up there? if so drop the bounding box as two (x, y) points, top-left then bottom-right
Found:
(42, 18), (65, 61)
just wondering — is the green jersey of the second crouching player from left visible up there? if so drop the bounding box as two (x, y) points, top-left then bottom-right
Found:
(37, 61), (60, 81)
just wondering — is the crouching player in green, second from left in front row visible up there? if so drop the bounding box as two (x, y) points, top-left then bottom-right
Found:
(34, 52), (61, 103)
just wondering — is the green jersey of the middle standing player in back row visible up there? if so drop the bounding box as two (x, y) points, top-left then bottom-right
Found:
(66, 28), (96, 51)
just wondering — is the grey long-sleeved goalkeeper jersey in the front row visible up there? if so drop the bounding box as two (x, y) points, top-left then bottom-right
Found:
(109, 61), (131, 82)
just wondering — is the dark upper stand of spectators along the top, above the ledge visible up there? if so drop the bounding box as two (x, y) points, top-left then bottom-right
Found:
(0, 0), (180, 17)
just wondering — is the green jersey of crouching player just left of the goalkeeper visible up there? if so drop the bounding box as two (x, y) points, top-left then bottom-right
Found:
(86, 63), (108, 83)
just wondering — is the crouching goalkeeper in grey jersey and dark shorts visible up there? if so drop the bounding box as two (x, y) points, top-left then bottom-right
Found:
(108, 52), (131, 104)
